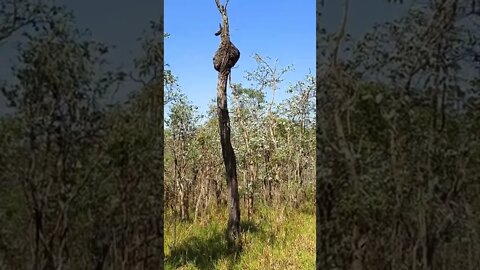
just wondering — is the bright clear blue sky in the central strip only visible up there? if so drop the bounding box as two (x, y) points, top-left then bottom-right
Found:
(165, 0), (316, 113)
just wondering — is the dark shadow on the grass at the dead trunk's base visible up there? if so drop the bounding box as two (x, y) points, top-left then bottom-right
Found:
(165, 221), (262, 270)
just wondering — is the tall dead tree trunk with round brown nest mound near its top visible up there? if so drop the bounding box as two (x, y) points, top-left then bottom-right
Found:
(213, 0), (241, 248)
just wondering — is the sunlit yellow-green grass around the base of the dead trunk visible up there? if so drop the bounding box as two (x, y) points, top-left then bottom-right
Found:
(165, 203), (315, 270)
